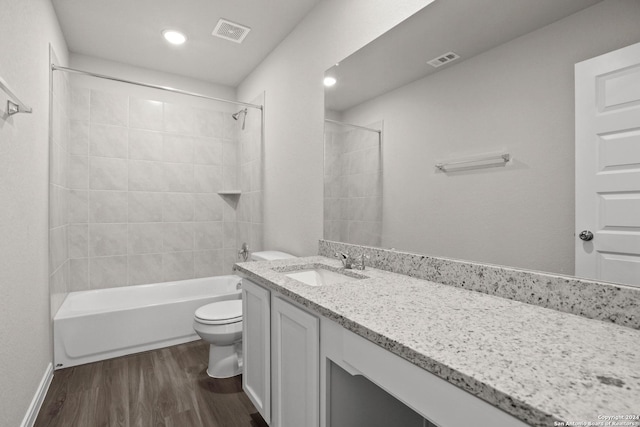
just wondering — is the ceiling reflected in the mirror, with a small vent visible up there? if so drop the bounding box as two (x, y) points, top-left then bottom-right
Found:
(325, 0), (602, 112)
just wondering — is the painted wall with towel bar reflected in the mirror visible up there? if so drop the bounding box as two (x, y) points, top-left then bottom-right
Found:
(342, 0), (640, 274)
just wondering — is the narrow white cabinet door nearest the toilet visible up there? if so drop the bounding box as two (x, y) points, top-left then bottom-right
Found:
(242, 279), (271, 424)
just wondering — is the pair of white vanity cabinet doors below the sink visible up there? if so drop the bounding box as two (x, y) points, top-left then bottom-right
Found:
(242, 279), (320, 427)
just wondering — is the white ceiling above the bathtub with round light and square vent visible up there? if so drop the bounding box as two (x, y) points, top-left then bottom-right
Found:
(52, 0), (320, 87)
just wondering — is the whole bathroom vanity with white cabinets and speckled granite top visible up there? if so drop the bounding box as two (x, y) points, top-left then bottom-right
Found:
(236, 256), (640, 427)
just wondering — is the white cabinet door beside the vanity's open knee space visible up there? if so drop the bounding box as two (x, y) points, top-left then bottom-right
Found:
(271, 297), (320, 427)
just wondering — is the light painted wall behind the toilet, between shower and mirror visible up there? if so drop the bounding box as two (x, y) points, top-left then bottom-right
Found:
(238, 0), (430, 255)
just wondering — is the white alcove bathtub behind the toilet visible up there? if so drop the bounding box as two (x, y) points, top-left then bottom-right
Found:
(53, 276), (241, 369)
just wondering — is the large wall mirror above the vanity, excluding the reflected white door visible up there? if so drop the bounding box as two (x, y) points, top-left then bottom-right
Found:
(324, 0), (640, 284)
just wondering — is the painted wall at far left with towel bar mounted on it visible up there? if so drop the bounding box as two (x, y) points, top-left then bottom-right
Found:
(0, 0), (67, 426)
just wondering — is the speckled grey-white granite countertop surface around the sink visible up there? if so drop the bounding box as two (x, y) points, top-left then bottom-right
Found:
(236, 256), (640, 426)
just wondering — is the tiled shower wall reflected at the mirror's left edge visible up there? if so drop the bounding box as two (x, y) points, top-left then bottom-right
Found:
(324, 122), (382, 246)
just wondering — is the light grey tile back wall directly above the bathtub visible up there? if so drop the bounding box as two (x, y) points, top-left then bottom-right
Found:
(67, 83), (245, 291)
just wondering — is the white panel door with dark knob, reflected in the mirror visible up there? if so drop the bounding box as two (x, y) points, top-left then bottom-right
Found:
(575, 43), (640, 286)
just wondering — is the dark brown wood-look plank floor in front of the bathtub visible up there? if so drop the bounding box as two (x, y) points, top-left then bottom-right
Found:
(35, 341), (267, 427)
